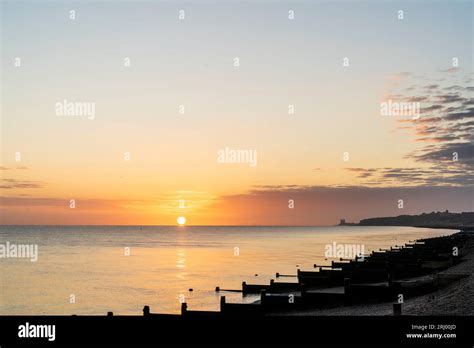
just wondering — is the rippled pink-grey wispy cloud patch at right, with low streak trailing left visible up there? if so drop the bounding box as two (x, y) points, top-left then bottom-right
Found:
(378, 68), (474, 186)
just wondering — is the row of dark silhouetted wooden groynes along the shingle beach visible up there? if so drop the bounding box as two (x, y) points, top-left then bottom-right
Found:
(144, 232), (474, 317)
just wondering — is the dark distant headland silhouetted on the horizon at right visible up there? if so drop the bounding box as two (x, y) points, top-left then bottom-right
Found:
(339, 210), (474, 229)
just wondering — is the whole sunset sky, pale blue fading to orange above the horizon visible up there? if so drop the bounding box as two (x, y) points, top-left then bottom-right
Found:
(0, 1), (474, 225)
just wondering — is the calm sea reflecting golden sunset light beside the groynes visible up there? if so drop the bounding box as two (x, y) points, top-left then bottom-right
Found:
(0, 226), (453, 315)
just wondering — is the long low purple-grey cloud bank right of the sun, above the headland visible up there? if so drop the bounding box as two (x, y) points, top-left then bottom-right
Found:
(205, 185), (473, 225)
